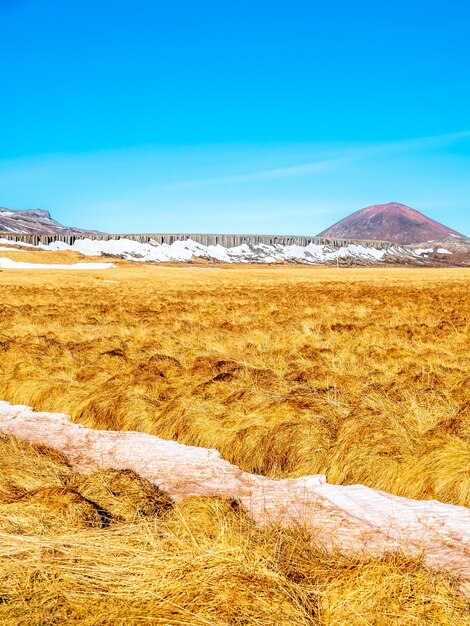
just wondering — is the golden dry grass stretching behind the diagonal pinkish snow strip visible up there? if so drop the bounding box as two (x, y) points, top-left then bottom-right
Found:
(0, 265), (470, 505)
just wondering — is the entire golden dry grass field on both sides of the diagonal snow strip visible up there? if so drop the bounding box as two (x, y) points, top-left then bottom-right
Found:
(0, 252), (470, 626)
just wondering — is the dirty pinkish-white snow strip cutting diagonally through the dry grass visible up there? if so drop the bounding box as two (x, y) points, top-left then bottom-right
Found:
(0, 402), (470, 595)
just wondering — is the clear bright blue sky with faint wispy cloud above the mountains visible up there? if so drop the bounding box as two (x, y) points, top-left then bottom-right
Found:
(0, 0), (470, 235)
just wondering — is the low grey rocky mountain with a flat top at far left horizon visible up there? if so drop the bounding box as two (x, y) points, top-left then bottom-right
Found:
(0, 207), (101, 235)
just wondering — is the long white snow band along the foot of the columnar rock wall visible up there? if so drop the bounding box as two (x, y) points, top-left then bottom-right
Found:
(0, 238), (419, 265)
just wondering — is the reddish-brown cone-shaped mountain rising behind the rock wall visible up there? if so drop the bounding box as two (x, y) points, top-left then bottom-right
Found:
(318, 202), (465, 244)
